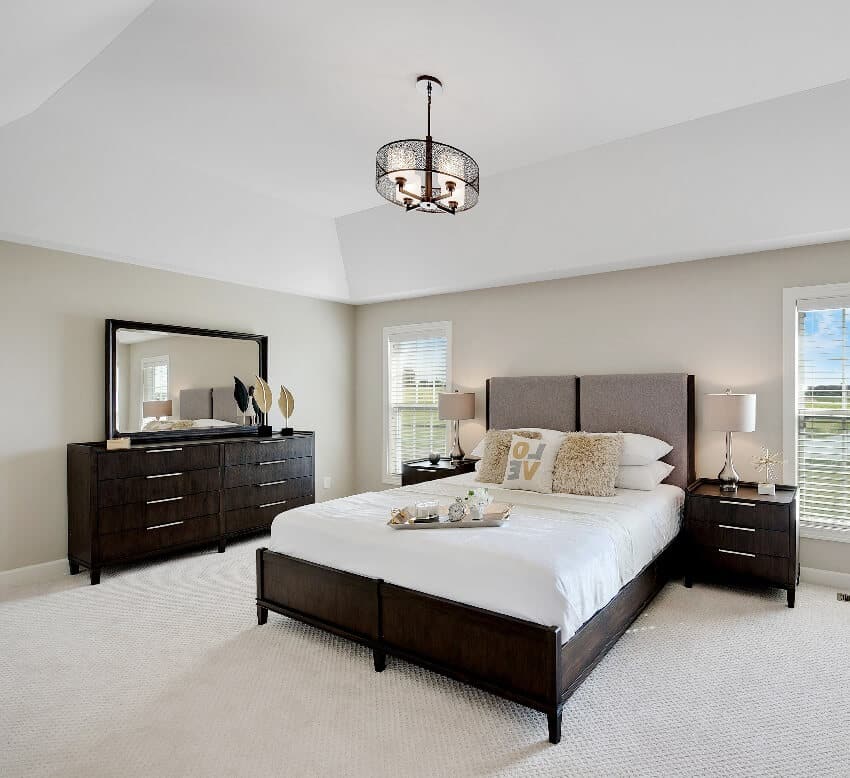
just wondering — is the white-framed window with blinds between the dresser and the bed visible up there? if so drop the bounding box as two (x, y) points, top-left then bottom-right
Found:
(384, 322), (452, 484)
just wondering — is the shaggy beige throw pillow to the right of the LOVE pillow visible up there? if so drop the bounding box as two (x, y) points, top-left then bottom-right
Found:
(552, 432), (623, 497)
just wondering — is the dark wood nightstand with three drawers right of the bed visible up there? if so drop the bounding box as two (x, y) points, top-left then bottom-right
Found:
(684, 479), (800, 608)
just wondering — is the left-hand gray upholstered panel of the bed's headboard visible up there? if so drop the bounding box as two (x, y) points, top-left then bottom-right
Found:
(487, 375), (577, 432)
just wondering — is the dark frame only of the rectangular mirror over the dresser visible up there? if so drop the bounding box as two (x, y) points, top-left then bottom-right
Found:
(106, 319), (269, 442)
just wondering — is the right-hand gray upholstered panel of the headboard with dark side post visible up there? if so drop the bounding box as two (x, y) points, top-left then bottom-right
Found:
(580, 373), (695, 489)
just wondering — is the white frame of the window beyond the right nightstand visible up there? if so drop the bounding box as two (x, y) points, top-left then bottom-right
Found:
(782, 283), (850, 543)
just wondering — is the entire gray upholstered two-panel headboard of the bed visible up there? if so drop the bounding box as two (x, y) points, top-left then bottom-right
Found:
(480, 373), (695, 489)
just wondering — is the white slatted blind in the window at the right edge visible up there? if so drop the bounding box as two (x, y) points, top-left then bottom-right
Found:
(796, 298), (850, 529)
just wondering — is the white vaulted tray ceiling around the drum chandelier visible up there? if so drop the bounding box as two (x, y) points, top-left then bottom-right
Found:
(0, 0), (850, 302)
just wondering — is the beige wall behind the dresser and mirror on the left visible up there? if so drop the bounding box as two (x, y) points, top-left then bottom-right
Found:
(0, 242), (354, 571)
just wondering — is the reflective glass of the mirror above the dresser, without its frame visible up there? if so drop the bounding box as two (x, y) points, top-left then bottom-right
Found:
(115, 329), (259, 433)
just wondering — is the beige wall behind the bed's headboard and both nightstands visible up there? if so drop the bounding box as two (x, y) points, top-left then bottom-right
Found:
(355, 243), (850, 572)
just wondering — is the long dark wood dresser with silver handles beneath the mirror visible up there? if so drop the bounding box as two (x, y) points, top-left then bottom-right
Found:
(68, 432), (315, 584)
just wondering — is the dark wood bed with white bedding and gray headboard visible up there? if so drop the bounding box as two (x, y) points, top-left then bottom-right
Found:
(257, 374), (694, 743)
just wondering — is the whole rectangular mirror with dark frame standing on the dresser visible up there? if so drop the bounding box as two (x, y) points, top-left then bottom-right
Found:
(106, 319), (268, 440)
